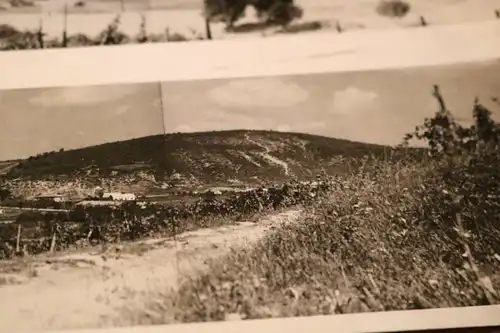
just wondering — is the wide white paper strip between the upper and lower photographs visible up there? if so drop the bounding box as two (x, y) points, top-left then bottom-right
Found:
(0, 20), (500, 89)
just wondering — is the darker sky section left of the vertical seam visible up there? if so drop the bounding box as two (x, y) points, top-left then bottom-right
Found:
(0, 83), (164, 160)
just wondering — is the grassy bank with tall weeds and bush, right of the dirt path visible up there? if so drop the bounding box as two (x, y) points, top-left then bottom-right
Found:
(121, 87), (500, 324)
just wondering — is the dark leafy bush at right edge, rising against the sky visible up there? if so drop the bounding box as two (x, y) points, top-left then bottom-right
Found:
(405, 86), (500, 262)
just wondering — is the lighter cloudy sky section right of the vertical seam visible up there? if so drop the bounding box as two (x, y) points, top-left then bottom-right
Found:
(162, 61), (500, 145)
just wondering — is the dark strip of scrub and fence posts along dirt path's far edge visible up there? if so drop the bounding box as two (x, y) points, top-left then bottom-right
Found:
(0, 179), (327, 259)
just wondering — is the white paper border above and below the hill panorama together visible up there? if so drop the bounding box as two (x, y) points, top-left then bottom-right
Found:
(0, 20), (500, 333)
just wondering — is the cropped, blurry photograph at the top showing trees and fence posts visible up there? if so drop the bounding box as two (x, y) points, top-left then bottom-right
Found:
(0, 0), (500, 51)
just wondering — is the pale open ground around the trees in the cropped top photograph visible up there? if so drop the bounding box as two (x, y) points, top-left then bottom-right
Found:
(0, 0), (500, 38)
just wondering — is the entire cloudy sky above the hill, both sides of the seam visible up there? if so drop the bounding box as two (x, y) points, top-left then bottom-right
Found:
(0, 61), (500, 160)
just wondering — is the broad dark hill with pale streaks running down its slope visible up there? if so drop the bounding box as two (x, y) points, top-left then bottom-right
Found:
(4, 130), (420, 191)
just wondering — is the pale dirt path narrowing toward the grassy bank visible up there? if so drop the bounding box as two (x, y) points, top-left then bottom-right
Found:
(0, 210), (300, 332)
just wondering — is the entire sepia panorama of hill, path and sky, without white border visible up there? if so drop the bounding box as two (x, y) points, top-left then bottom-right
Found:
(0, 60), (500, 331)
